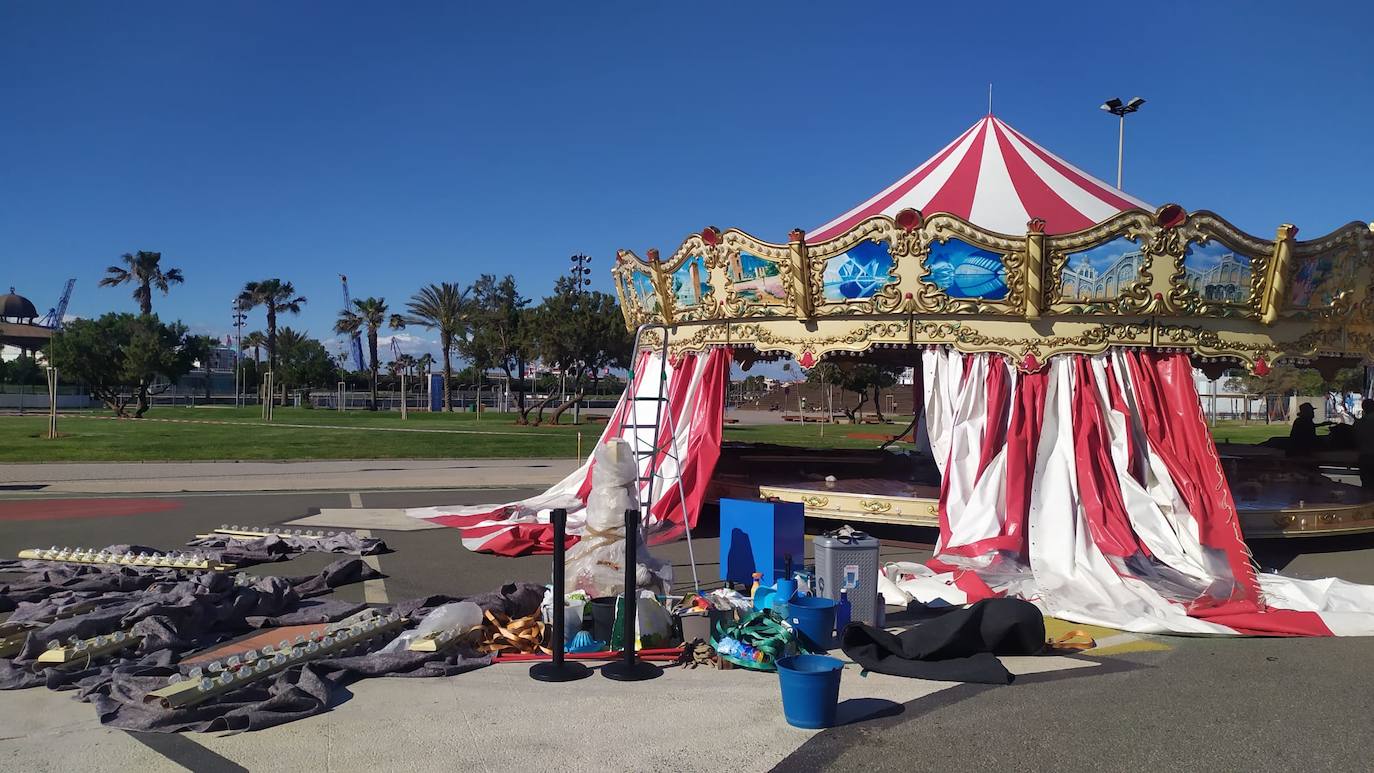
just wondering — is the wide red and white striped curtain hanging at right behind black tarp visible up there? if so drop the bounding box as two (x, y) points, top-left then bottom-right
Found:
(922, 349), (1374, 636)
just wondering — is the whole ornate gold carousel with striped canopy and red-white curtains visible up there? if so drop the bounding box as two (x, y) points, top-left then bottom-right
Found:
(409, 115), (1374, 636)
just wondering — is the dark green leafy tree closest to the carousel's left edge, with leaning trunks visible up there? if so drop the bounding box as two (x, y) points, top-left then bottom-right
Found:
(533, 276), (633, 424)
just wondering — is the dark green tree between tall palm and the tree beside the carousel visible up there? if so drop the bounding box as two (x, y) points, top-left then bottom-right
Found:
(458, 273), (536, 424)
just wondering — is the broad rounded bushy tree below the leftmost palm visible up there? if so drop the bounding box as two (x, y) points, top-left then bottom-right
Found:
(48, 313), (191, 417)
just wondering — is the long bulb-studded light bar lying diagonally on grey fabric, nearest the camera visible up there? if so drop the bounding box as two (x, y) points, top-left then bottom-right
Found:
(143, 612), (409, 708)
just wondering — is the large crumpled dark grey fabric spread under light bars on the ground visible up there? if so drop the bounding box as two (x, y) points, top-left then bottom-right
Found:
(0, 557), (544, 732)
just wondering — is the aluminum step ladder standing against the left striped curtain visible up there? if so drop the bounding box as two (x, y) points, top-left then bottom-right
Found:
(621, 323), (701, 592)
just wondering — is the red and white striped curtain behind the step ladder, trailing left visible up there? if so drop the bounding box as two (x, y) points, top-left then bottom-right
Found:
(407, 349), (731, 556)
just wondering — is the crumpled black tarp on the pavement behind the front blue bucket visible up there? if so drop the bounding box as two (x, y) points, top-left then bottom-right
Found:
(841, 599), (1044, 684)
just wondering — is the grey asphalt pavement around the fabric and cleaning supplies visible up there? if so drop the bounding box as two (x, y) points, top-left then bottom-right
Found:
(0, 487), (1374, 772)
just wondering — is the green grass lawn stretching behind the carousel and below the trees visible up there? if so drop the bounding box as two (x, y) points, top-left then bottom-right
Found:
(0, 408), (1287, 463)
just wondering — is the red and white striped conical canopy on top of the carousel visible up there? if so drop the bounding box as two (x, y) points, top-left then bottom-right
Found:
(807, 115), (1154, 243)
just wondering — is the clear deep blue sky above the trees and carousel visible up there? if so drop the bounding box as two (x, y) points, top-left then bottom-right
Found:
(0, 0), (1374, 359)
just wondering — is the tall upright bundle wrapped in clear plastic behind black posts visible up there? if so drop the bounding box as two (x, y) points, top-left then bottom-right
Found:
(565, 439), (673, 599)
